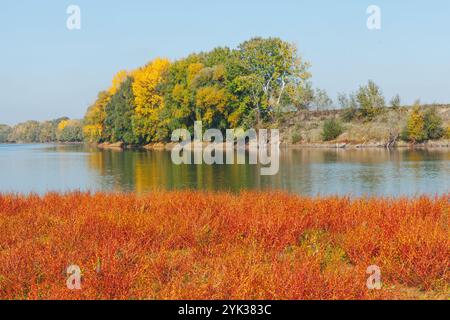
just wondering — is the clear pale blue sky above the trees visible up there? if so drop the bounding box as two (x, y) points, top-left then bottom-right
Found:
(0, 0), (450, 124)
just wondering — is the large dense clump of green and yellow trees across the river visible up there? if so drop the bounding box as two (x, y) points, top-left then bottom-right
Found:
(83, 38), (310, 144)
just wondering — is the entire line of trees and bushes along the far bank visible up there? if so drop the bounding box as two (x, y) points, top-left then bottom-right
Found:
(0, 38), (449, 145)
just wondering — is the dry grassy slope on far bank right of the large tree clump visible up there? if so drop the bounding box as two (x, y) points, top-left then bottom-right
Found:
(280, 105), (450, 147)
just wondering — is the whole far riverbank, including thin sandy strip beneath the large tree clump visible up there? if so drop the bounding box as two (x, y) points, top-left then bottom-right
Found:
(99, 105), (450, 150)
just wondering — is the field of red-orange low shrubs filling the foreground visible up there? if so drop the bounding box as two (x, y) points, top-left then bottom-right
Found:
(0, 191), (450, 300)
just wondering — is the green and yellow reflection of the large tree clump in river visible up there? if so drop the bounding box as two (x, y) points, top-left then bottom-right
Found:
(88, 150), (266, 193)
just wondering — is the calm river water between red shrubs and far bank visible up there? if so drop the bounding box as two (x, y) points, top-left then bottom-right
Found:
(0, 145), (450, 196)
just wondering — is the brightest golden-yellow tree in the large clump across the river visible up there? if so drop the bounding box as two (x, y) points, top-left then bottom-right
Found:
(133, 58), (170, 142)
